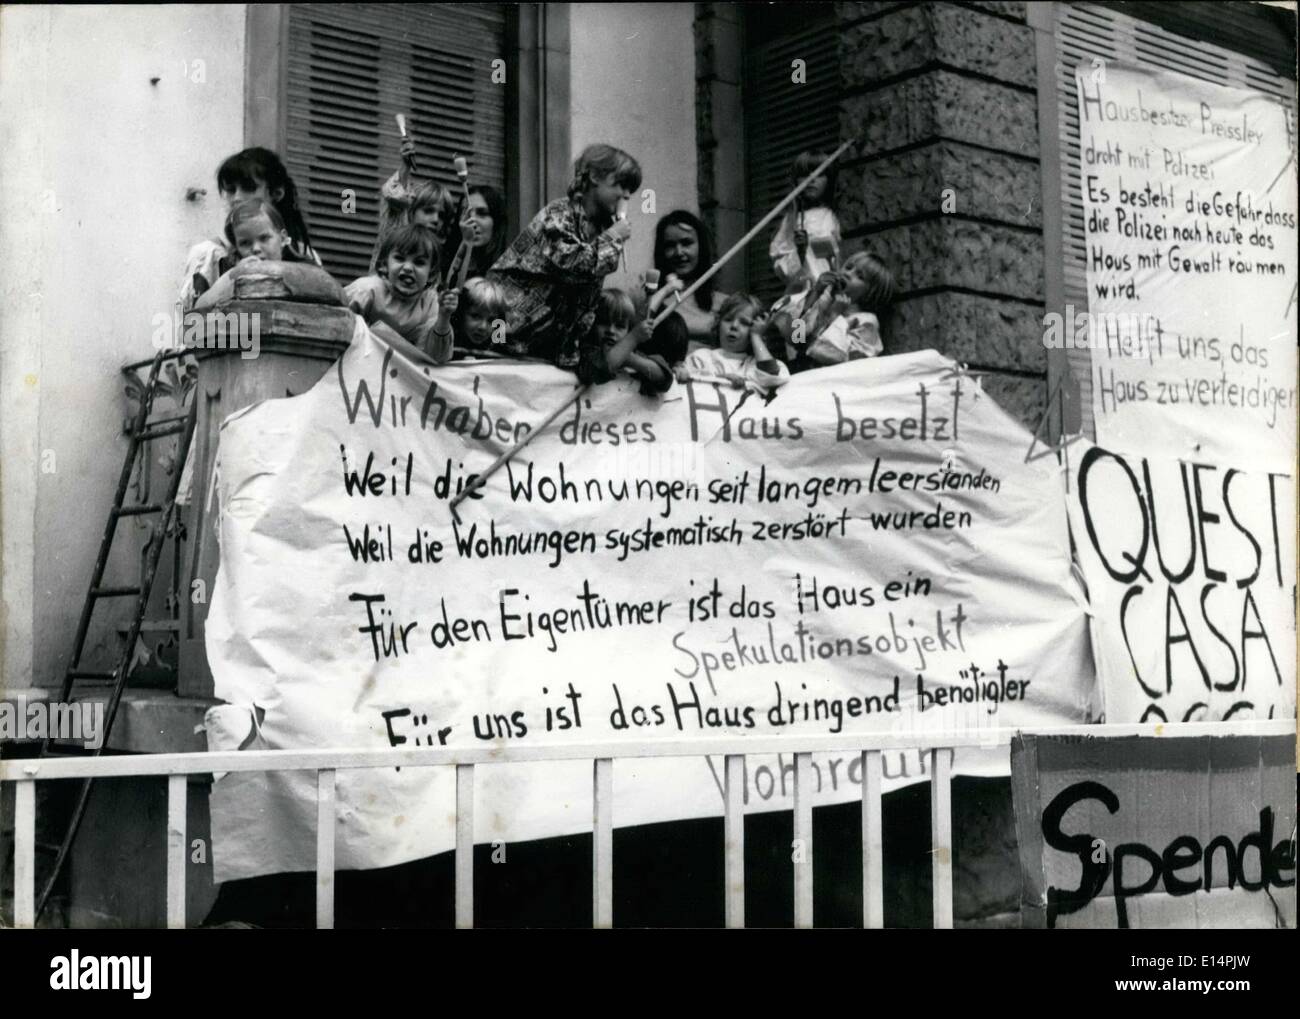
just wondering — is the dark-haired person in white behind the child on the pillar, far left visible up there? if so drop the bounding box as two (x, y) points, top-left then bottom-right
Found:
(179, 148), (321, 312)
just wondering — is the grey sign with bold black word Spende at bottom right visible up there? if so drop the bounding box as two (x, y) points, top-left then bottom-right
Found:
(1011, 736), (1296, 930)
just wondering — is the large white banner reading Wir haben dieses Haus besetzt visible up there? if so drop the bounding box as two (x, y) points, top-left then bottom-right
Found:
(207, 320), (1097, 881)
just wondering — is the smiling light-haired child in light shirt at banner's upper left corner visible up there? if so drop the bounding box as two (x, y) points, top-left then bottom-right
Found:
(343, 224), (459, 364)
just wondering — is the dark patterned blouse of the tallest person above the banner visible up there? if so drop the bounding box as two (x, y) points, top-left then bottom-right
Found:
(488, 198), (623, 382)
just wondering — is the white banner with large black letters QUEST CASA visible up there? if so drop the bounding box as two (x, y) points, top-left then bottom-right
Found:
(1070, 441), (1296, 723)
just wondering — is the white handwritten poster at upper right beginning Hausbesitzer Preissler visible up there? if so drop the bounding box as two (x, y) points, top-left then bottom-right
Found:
(1071, 64), (1297, 471)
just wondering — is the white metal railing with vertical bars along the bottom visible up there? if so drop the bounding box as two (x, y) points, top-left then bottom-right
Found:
(0, 719), (1296, 928)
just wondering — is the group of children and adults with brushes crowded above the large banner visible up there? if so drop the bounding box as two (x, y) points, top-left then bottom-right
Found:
(182, 140), (893, 394)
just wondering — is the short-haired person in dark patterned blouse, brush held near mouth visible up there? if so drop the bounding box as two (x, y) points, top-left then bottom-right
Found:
(488, 144), (641, 382)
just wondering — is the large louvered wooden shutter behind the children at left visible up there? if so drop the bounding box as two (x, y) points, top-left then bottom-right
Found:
(286, 4), (506, 283)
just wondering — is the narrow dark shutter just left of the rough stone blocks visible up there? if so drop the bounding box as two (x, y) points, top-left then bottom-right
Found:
(742, 4), (840, 302)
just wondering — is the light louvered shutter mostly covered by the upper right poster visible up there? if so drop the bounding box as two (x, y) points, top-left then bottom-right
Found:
(1056, 4), (1296, 438)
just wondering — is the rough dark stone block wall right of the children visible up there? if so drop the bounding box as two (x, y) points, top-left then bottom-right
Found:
(836, 3), (1047, 429)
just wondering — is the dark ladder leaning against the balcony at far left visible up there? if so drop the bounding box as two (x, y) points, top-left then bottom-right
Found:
(35, 350), (199, 923)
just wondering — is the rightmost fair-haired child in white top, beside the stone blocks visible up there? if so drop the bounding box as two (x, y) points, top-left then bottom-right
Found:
(801, 251), (894, 365)
